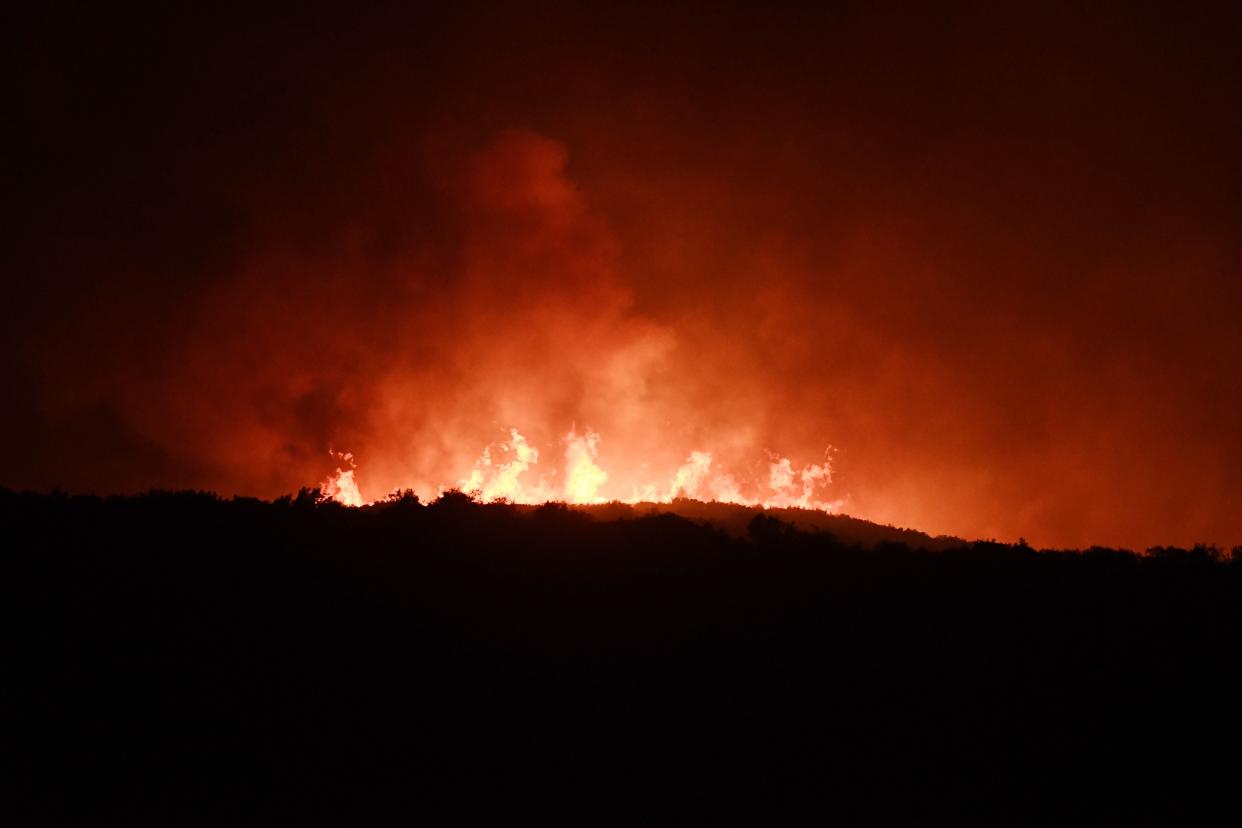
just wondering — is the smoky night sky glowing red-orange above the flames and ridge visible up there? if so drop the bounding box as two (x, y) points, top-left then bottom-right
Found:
(9, 2), (1242, 549)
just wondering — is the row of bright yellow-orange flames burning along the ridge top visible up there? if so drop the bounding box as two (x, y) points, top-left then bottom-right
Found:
(320, 427), (842, 511)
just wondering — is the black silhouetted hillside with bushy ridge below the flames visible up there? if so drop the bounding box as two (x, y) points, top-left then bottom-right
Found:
(9, 494), (1242, 824)
